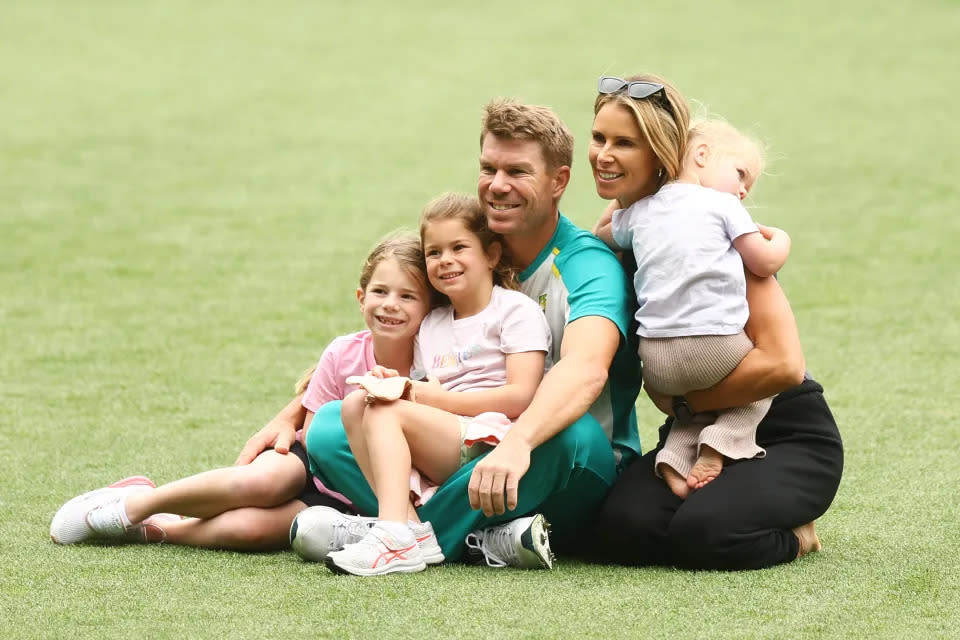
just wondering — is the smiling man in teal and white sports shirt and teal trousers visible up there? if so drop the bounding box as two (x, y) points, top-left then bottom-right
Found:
(238, 100), (640, 566)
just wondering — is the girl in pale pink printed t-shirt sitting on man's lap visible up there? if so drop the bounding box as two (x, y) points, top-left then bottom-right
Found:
(326, 194), (550, 576)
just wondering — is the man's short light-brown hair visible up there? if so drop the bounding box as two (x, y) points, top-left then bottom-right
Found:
(480, 98), (573, 170)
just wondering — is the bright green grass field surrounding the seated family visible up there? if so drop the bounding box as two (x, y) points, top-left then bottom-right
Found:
(0, 0), (960, 639)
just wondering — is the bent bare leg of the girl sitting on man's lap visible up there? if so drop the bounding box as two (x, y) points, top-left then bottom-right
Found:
(363, 400), (460, 523)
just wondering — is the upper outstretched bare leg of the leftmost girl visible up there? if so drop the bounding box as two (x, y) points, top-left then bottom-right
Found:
(126, 450), (307, 524)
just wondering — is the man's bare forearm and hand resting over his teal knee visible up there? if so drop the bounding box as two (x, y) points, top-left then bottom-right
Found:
(468, 316), (620, 516)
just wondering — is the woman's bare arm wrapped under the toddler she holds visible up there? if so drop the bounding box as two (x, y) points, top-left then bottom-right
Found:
(684, 271), (806, 411)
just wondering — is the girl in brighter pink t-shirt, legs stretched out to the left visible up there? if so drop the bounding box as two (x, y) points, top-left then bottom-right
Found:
(50, 235), (432, 559)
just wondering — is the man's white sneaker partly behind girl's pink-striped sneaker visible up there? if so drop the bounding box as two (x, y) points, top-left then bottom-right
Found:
(290, 507), (377, 562)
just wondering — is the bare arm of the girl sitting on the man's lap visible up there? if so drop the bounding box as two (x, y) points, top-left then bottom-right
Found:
(413, 351), (546, 419)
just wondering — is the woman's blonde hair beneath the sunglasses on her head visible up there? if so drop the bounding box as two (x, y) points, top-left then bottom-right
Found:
(593, 74), (690, 189)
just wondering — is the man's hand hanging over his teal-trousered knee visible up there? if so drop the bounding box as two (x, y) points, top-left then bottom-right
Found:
(467, 433), (530, 517)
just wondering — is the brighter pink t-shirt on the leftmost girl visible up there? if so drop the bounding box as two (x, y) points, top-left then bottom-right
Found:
(302, 329), (377, 413)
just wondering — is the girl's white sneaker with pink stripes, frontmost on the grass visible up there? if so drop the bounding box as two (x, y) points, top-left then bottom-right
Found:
(326, 525), (427, 576)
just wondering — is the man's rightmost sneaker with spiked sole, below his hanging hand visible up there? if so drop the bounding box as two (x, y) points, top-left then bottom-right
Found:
(464, 513), (553, 569)
